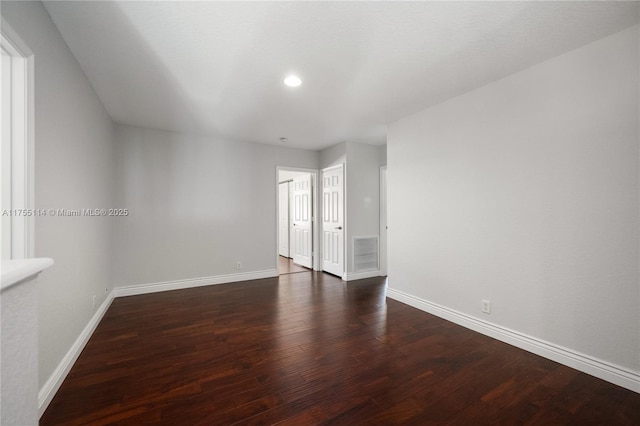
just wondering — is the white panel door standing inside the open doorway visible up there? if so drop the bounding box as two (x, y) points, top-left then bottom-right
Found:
(293, 174), (313, 268)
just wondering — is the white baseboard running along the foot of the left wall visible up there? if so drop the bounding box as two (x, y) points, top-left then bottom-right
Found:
(38, 291), (114, 417)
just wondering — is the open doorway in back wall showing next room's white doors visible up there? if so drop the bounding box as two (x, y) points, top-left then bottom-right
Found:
(277, 167), (318, 275)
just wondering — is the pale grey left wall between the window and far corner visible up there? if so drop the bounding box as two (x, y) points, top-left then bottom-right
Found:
(2, 2), (114, 386)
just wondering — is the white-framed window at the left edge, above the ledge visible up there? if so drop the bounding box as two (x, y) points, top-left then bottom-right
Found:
(0, 19), (36, 259)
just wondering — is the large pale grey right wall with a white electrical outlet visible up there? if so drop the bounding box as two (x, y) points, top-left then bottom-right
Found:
(388, 26), (640, 377)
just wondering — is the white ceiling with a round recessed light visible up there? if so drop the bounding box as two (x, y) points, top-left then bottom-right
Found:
(45, 1), (639, 149)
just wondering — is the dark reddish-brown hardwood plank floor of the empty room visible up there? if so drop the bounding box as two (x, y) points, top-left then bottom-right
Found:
(41, 272), (640, 425)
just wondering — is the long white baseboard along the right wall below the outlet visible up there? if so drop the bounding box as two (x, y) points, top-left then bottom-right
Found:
(387, 288), (640, 393)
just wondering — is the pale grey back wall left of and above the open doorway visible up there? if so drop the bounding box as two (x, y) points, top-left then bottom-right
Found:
(114, 126), (319, 286)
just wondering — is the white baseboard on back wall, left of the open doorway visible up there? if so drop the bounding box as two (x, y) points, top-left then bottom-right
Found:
(114, 269), (278, 297)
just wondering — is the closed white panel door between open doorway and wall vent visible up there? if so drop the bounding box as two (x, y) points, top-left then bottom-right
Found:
(322, 165), (344, 277)
